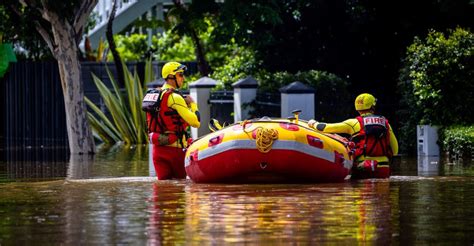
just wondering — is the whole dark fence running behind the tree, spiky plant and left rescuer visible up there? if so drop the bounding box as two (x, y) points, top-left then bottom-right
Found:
(0, 61), (198, 160)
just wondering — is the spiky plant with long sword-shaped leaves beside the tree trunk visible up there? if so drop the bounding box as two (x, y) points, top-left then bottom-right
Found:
(86, 60), (154, 145)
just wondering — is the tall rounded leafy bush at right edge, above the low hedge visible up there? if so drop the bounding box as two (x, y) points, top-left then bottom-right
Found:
(408, 28), (474, 124)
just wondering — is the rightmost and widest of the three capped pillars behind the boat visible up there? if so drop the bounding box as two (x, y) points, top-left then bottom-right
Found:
(280, 81), (315, 120)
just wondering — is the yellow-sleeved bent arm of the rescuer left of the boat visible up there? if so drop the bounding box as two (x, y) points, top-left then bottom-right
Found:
(168, 93), (201, 128)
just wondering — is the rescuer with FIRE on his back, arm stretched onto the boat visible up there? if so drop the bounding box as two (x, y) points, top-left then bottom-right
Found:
(308, 93), (398, 179)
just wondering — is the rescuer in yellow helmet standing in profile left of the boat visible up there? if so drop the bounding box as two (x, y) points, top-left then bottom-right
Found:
(144, 62), (200, 180)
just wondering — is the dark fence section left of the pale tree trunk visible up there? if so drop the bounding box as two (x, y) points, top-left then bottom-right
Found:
(1, 62), (68, 159)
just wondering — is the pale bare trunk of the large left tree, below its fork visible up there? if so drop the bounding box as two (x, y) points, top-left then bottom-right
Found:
(49, 13), (95, 154)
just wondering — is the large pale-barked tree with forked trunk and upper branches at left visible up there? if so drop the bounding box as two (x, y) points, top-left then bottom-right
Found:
(10, 0), (98, 154)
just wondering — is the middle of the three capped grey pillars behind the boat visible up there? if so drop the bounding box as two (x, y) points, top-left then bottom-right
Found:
(232, 76), (258, 122)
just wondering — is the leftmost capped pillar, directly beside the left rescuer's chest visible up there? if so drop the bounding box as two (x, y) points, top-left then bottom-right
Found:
(189, 77), (217, 139)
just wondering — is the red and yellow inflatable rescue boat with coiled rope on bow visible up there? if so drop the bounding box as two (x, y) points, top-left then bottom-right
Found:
(185, 117), (352, 183)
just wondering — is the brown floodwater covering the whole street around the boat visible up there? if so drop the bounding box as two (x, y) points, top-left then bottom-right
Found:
(0, 147), (474, 245)
